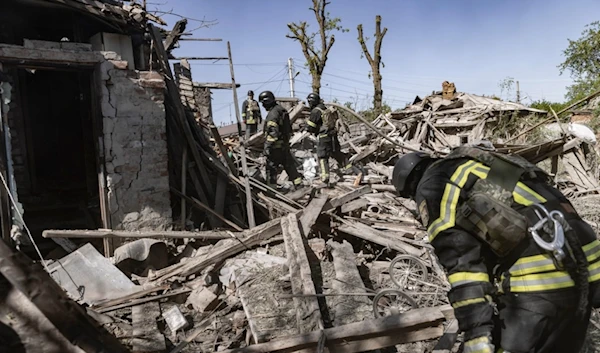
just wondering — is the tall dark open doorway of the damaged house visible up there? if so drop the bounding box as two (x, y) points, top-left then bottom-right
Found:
(19, 69), (101, 249)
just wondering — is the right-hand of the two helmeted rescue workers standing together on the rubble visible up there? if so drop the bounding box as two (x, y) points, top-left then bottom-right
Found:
(306, 93), (352, 187)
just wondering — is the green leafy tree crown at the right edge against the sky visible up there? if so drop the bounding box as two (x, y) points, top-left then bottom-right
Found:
(558, 21), (600, 100)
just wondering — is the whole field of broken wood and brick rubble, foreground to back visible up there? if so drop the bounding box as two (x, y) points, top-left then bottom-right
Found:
(36, 82), (599, 352)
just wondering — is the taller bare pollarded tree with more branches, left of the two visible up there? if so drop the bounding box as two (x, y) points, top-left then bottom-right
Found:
(286, 0), (348, 93)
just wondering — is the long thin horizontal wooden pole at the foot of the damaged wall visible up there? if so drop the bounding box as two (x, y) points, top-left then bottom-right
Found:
(42, 229), (231, 240)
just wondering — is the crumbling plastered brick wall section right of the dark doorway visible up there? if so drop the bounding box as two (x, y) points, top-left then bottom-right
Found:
(100, 53), (172, 230)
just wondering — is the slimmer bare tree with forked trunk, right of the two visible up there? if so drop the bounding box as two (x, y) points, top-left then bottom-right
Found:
(356, 15), (387, 115)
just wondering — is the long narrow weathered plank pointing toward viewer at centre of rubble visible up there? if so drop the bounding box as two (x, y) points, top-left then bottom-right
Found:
(281, 213), (324, 333)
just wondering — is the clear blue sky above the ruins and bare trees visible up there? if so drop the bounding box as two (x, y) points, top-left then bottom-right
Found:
(158, 0), (600, 125)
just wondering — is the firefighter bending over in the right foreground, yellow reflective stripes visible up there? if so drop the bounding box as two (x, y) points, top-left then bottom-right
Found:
(392, 146), (600, 353)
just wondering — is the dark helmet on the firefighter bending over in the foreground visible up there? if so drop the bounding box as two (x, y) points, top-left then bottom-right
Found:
(392, 152), (431, 197)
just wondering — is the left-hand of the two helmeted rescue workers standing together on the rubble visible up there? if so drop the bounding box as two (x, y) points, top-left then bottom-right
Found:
(258, 91), (302, 189)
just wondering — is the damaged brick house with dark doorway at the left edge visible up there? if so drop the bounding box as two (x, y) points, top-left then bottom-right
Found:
(0, 0), (172, 258)
